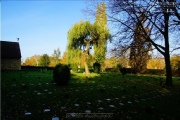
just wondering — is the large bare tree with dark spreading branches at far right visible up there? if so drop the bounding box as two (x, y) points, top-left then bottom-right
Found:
(108, 0), (180, 86)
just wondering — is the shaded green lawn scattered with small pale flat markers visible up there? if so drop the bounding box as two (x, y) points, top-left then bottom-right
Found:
(1, 71), (180, 120)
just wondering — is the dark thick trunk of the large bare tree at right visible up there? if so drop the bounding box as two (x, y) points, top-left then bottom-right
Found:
(164, 13), (172, 86)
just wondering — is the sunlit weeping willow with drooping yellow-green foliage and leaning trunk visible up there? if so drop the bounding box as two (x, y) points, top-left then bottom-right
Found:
(68, 21), (99, 77)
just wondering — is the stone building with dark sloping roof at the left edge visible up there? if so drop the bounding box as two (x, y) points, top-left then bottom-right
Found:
(0, 41), (21, 70)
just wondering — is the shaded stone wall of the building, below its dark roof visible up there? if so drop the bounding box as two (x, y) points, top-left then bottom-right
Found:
(1, 58), (21, 70)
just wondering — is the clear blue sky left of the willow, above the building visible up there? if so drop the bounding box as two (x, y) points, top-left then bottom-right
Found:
(1, 0), (89, 61)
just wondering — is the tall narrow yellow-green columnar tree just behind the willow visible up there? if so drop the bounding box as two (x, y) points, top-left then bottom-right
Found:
(94, 2), (110, 63)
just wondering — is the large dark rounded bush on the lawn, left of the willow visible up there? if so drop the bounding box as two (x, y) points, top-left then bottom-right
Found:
(53, 64), (71, 86)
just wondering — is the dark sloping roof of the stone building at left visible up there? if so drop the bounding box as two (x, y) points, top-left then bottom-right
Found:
(0, 41), (21, 58)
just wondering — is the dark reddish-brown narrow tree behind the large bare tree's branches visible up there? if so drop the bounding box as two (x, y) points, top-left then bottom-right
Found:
(130, 14), (152, 73)
